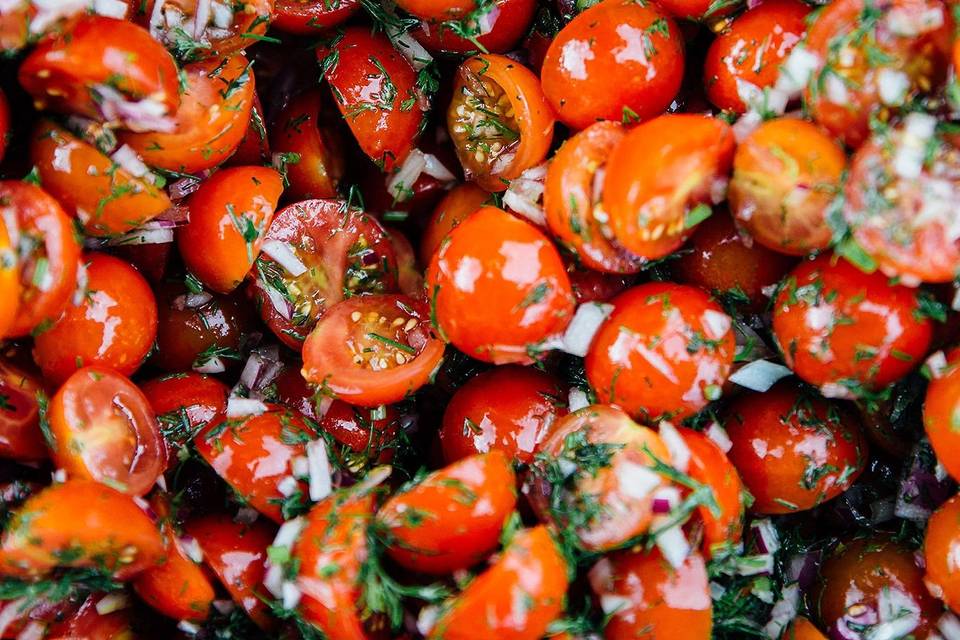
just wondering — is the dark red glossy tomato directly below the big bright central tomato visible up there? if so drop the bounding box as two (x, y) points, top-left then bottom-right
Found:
(440, 365), (567, 464)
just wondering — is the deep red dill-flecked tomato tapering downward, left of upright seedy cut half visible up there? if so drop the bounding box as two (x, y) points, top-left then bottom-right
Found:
(317, 27), (423, 171)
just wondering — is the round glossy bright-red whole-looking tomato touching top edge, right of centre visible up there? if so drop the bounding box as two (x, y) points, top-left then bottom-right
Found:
(542, 0), (684, 131)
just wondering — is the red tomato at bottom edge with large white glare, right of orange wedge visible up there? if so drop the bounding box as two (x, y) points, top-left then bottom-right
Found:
(589, 547), (713, 640)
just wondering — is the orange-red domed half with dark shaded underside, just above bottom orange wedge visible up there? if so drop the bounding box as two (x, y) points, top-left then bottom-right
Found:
(377, 449), (517, 575)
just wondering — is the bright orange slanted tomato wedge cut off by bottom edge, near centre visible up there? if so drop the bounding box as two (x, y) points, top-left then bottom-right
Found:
(427, 526), (568, 640)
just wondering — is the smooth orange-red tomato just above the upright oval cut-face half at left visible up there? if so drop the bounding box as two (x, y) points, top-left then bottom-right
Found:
(33, 252), (157, 384)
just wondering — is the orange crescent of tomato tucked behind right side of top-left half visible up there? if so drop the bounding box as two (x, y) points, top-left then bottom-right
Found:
(118, 54), (254, 173)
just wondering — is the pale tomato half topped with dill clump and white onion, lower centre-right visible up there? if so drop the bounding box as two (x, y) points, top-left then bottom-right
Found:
(529, 405), (670, 551)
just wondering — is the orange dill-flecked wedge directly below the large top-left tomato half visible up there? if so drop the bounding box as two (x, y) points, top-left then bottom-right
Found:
(30, 120), (172, 236)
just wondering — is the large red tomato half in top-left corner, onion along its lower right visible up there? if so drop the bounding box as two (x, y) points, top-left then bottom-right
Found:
(17, 15), (180, 131)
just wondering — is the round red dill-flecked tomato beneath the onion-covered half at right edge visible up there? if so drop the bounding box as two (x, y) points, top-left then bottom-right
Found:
(773, 255), (933, 398)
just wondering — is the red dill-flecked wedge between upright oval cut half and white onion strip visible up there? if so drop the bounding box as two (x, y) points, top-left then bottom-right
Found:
(193, 407), (317, 522)
